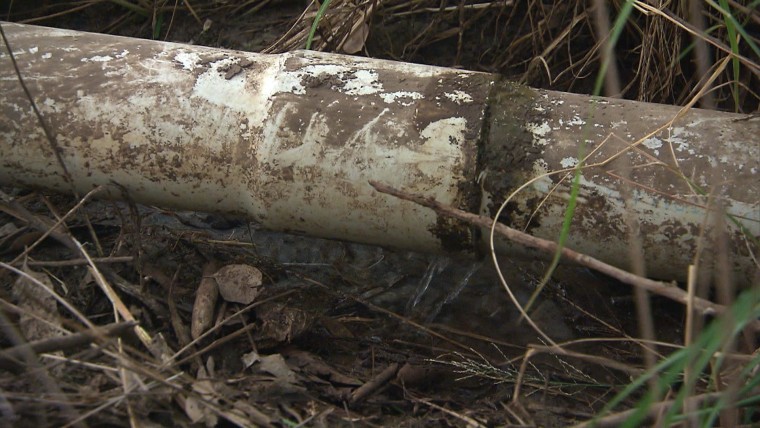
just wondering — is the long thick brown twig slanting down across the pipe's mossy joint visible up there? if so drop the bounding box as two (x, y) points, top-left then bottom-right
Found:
(369, 181), (760, 330)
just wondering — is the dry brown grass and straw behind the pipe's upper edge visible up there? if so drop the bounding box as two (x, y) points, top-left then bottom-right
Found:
(6, 0), (760, 108)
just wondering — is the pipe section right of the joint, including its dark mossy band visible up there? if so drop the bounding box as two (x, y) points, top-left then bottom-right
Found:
(482, 83), (760, 284)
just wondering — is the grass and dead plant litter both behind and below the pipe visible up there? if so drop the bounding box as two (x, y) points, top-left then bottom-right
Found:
(0, 0), (760, 427)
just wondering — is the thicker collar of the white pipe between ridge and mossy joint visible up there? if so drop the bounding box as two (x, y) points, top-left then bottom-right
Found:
(251, 52), (492, 251)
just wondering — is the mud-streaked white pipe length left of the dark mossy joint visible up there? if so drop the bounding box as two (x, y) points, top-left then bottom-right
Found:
(0, 24), (491, 251)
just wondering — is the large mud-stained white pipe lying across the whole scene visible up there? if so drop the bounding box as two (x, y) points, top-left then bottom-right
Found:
(0, 24), (760, 279)
